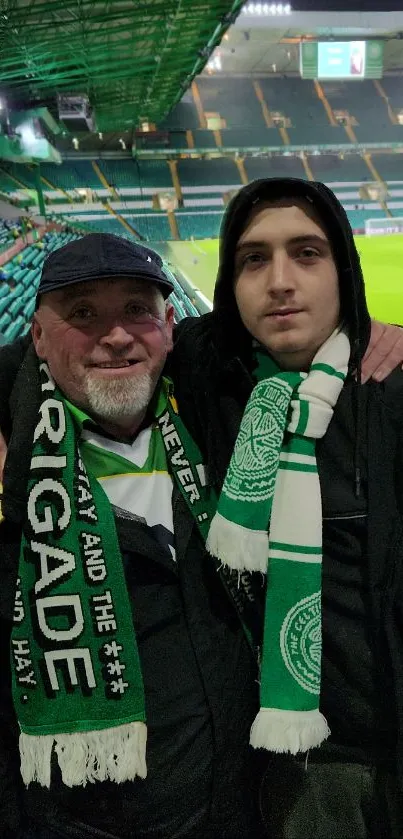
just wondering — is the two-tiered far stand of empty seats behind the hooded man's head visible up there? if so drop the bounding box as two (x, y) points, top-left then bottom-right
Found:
(0, 75), (403, 250)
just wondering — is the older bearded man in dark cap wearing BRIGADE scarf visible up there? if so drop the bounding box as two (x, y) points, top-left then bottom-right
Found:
(0, 234), (260, 839)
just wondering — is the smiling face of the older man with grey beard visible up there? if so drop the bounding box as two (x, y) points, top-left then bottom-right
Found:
(32, 278), (173, 430)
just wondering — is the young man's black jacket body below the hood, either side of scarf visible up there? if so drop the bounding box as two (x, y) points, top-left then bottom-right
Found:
(171, 313), (403, 781)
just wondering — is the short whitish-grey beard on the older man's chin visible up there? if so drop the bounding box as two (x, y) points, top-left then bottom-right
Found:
(85, 373), (156, 422)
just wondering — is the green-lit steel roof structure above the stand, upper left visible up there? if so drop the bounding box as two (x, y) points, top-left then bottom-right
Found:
(0, 0), (243, 131)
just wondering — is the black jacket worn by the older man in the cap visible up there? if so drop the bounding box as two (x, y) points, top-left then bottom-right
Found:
(0, 344), (266, 839)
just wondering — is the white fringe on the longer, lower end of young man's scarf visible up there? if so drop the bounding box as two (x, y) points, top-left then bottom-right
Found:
(250, 708), (330, 755)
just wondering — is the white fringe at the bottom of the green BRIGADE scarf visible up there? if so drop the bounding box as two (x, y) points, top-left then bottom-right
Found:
(19, 722), (147, 788)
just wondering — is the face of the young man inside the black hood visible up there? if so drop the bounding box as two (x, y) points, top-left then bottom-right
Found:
(234, 199), (340, 370)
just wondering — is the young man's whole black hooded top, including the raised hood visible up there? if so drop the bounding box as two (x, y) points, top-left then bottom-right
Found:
(172, 178), (403, 768)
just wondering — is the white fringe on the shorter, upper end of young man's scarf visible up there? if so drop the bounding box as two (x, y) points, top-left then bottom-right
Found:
(206, 513), (269, 574)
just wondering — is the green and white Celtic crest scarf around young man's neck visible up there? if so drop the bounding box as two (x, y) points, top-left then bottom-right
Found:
(207, 331), (350, 754)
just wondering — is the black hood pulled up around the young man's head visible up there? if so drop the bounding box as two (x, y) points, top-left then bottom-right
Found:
(214, 178), (371, 367)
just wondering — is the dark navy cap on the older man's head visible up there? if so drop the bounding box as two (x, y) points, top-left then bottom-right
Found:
(36, 233), (173, 303)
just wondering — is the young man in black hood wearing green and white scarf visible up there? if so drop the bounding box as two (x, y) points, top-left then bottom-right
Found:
(172, 179), (403, 839)
